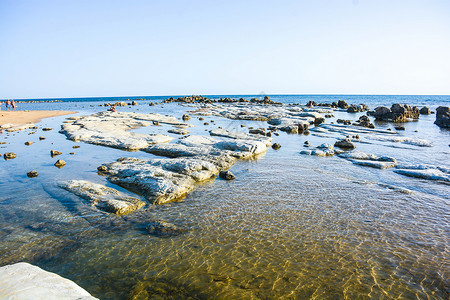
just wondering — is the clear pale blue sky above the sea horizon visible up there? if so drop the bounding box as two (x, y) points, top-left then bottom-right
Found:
(0, 0), (450, 99)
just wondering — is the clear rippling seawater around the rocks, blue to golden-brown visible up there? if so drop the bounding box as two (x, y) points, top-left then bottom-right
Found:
(0, 95), (450, 299)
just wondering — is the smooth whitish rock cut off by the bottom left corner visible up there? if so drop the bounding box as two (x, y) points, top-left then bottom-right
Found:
(0, 262), (97, 300)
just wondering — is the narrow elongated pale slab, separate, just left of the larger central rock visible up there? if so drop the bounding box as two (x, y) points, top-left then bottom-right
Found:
(58, 180), (145, 215)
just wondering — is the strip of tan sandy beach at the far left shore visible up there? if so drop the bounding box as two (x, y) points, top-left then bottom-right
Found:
(0, 110), (76, 125)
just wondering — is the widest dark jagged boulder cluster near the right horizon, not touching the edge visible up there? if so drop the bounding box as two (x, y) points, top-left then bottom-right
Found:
(368, 104), (420, 123)
